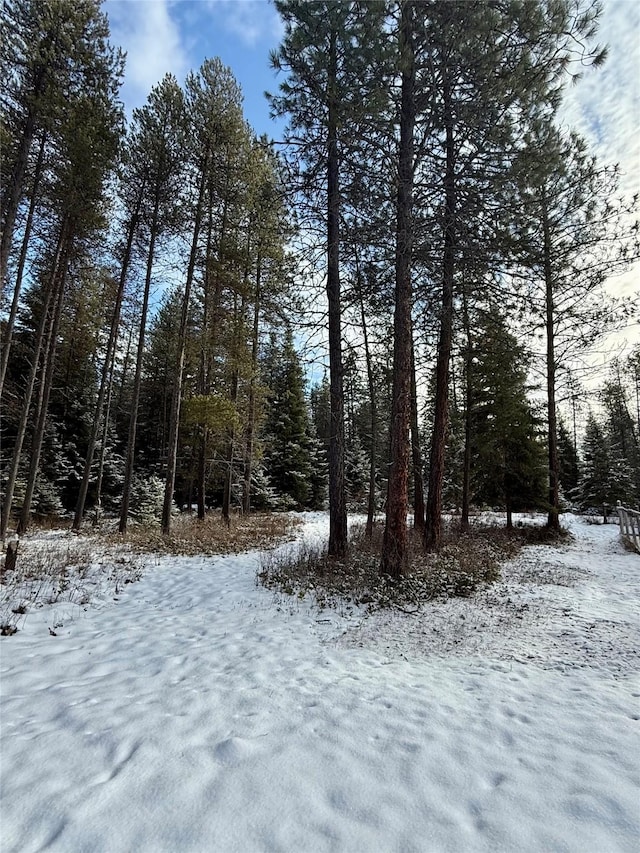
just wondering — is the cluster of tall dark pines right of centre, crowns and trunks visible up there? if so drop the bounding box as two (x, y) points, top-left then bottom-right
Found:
(271, 0), (637, 577)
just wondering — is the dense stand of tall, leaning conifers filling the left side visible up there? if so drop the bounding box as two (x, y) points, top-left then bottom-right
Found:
(2, 0), (298, 538)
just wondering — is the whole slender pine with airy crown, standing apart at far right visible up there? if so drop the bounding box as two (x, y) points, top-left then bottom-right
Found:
(516, 123), (639, 529)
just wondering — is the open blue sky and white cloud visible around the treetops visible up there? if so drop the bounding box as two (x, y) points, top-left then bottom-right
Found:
(104, 0), (640, 360)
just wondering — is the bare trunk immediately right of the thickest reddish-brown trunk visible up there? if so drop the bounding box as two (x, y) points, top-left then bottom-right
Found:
(424, 68), (456, 551)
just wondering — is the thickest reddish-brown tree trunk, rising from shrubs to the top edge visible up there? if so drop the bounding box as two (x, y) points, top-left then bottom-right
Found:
(380, 0), (415, 578)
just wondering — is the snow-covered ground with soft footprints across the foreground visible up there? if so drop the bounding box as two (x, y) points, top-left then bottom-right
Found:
(0, 515), (640, 853)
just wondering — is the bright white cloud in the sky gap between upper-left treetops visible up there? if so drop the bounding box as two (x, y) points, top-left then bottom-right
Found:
(104, 0), (189, 106)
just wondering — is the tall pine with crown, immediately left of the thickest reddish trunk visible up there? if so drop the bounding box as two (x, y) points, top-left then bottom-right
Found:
(271, 0), (382, 557)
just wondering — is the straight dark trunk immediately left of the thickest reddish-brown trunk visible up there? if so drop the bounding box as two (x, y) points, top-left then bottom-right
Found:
(327, 25), (347, 558)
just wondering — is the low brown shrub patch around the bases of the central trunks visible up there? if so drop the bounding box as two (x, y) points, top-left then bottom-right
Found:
(258, 527), (564, 612)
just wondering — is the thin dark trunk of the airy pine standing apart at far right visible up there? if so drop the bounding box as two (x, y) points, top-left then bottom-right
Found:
(541, 191), (560, 530)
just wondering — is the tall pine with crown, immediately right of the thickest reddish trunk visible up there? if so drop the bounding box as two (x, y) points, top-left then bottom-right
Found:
(418, 2), (597, 550)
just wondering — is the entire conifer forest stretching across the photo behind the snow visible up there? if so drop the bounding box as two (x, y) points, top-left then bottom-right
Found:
(0, 0), (640, 577)
